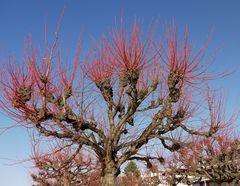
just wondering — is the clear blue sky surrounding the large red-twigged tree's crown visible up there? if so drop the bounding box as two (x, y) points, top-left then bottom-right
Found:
(0, 0), (240, 186)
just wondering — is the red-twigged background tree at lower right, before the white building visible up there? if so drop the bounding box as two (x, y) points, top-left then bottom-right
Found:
(167, 134), (240, 185)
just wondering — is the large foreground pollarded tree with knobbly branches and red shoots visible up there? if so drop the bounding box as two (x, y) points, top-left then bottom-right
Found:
(0, 21), (227, 186)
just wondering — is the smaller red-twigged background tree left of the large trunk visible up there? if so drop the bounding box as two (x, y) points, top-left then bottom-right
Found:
(31, 145), (100, 186)
